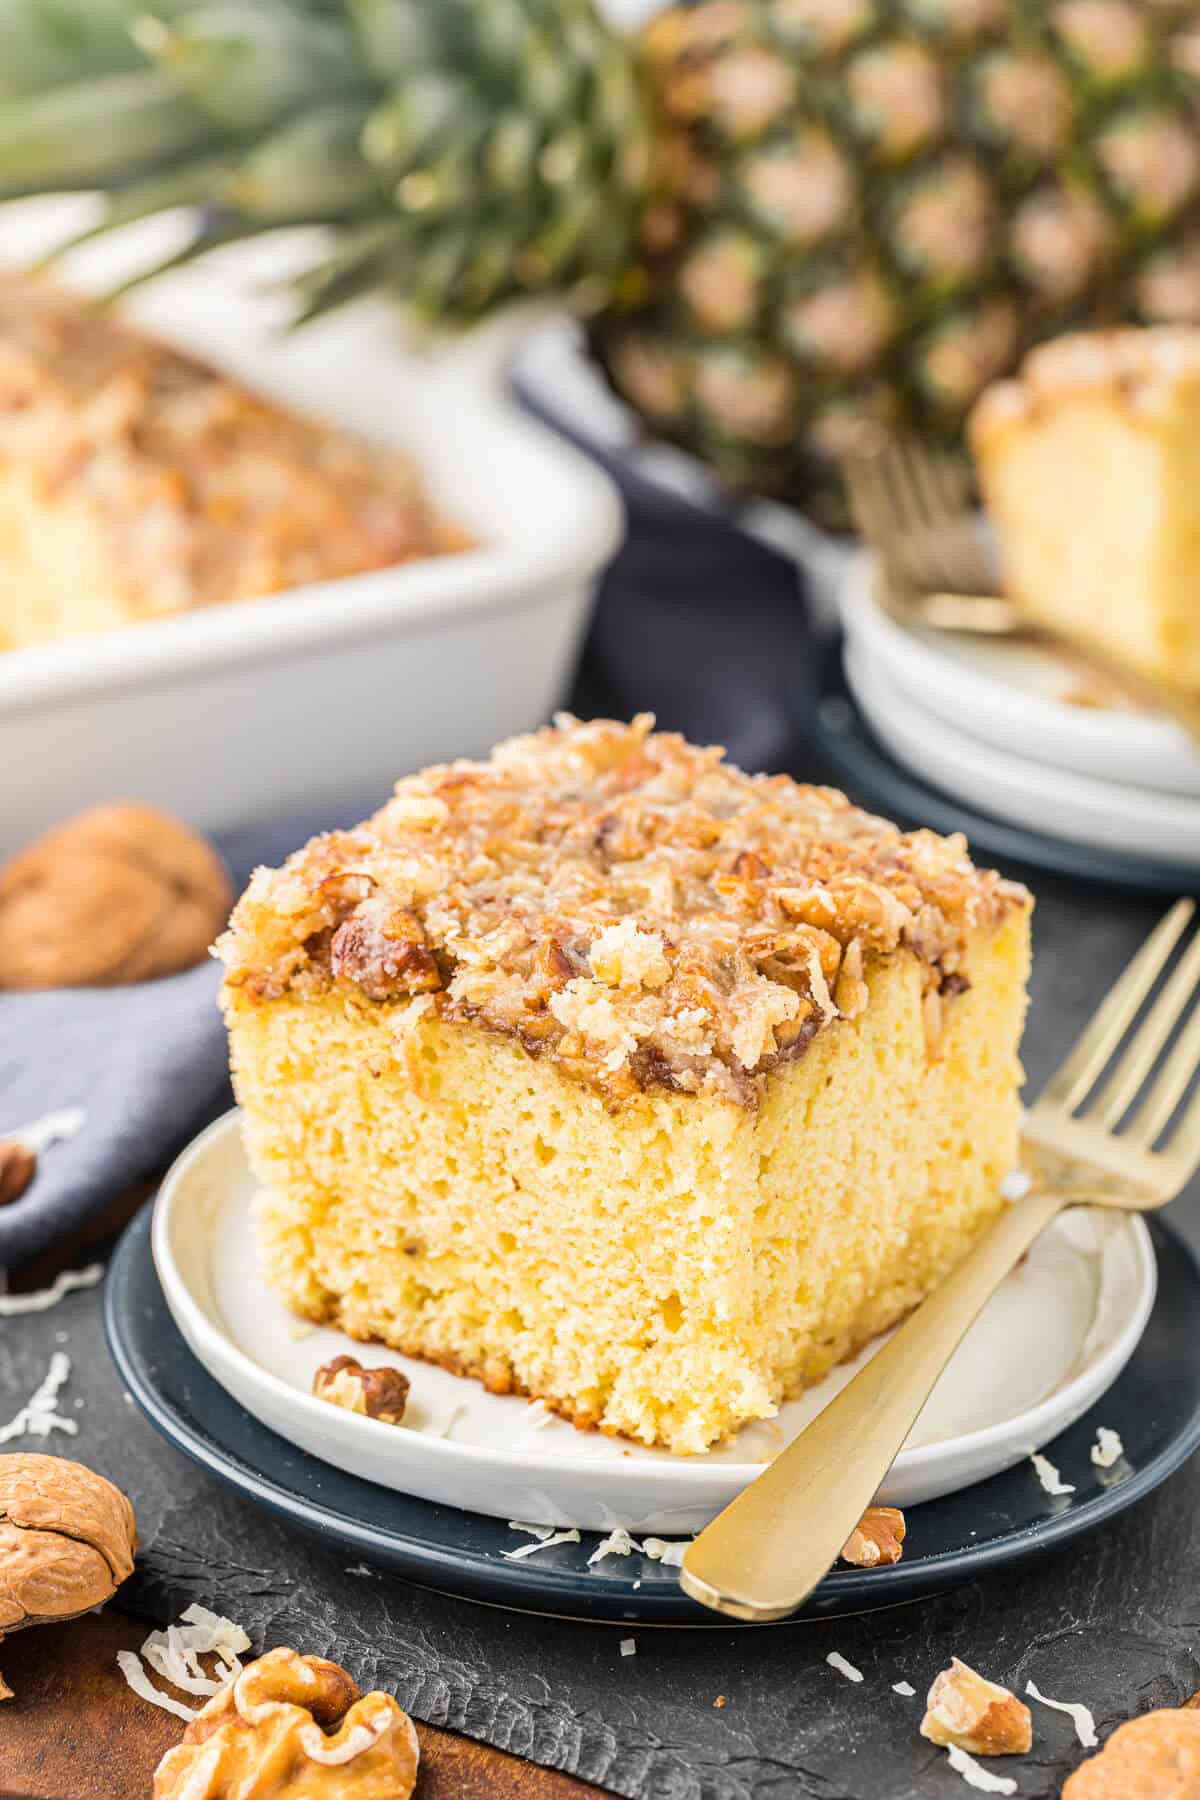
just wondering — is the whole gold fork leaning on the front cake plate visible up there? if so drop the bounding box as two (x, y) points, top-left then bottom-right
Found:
(680, 900), (1200, 1620)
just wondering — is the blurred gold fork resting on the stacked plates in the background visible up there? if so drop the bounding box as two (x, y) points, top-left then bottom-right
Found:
(842, 428), (1200, 740)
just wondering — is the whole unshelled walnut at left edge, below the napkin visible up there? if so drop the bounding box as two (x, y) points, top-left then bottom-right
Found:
(0, 1451), (137, 1699)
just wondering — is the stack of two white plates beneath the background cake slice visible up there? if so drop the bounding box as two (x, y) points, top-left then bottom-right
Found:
(840, 554), (1200, 868)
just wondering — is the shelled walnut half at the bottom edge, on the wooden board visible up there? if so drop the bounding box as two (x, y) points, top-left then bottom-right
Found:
(155, 1649), (419, 1800)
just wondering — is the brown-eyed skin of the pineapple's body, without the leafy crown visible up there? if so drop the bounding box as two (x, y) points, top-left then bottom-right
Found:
(592, 0), (1200, 524)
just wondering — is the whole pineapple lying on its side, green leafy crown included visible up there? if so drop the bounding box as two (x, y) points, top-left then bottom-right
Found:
(0, 0), (1200, 506)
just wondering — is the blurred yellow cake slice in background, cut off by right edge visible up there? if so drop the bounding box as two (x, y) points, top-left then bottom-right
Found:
(970, 326), (1200, 693)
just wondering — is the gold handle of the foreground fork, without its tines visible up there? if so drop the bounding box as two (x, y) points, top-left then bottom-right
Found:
(680, 1188), (1078, 1620)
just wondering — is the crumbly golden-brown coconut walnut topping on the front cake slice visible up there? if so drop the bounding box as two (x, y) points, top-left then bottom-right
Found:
(219, 715), (1029, 1105)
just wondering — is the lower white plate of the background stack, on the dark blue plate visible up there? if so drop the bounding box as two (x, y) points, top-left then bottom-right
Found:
(846, 641), (1200, 866)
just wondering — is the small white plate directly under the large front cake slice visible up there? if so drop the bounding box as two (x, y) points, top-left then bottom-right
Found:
(153, 1112), (1155, 1535)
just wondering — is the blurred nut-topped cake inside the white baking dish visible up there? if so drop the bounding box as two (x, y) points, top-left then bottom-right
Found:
(0, 275), (462, 650)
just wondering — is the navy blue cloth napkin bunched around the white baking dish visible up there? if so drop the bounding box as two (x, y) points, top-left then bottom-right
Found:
(0, 482), (808, 1269)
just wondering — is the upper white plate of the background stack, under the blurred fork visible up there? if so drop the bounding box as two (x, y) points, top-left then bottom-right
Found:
(838, 554), (1200, 795)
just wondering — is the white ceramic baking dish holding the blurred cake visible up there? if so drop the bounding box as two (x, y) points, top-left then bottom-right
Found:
(0, 202), (621, 853)
